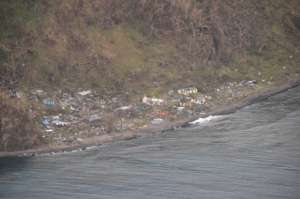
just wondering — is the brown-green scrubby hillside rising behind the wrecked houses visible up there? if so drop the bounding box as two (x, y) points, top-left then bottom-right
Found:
(0, 0), (300, 150)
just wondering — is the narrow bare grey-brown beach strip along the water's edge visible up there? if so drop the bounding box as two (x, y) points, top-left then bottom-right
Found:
(0, 80), (300, 158)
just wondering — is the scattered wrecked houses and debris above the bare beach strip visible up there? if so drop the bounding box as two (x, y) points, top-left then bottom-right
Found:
(7, 80), (256, 145)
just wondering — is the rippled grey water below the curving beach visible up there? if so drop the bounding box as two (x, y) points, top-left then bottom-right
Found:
(0, 88), (300, 199)
